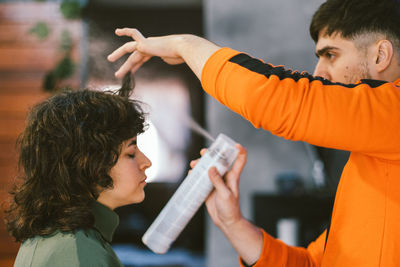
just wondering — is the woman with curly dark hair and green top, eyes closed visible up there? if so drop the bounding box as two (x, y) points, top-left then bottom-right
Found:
(6, 76), (151, 267)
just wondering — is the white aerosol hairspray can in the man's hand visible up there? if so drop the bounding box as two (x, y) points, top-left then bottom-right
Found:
(142, 134), (239, 254)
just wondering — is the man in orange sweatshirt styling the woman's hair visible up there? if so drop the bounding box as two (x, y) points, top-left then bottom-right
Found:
(108, 0), (400, 267)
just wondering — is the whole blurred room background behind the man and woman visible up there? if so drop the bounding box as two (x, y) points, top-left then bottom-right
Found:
(0, 0), (347, 267)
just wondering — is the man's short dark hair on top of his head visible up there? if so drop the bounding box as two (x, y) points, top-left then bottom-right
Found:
(310, 0), (400, 49)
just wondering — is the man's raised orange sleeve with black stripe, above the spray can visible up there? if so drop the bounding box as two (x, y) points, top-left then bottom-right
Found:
(201, 48), (400, 160)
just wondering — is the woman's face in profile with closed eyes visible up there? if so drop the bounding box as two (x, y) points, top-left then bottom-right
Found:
(97, 137), (151, 209)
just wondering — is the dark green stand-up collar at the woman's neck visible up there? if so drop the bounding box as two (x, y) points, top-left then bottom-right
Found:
(91, 201), (119, 243)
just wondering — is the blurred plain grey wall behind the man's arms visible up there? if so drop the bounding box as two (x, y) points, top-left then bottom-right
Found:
(204, 0), (323, 267)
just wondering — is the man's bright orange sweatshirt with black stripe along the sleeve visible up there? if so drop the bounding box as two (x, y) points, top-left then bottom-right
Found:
(201, 48), (400, 267)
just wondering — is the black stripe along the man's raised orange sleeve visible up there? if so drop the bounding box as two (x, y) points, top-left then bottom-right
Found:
(229, 53), (387, 88)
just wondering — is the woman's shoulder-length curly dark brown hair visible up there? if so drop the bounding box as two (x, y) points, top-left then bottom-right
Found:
(6, 77), (145, 242)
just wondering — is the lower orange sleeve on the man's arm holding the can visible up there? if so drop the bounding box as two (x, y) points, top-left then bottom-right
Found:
(239, 230), (326, 267)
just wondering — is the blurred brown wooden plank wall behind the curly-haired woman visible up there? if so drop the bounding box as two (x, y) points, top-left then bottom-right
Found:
(0, 1), (82, 258)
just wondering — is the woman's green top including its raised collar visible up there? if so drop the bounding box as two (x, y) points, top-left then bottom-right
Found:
(14, 201), (123, 267)
